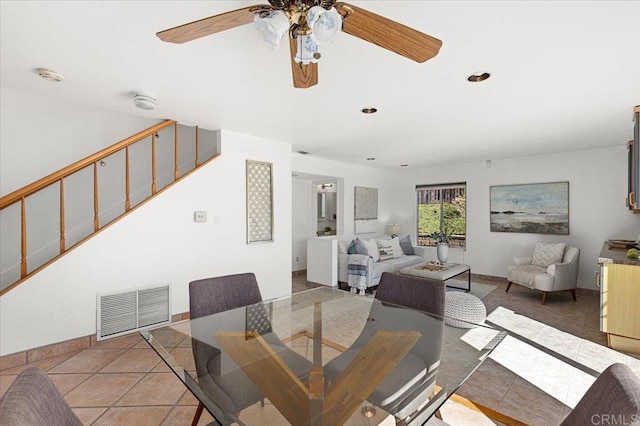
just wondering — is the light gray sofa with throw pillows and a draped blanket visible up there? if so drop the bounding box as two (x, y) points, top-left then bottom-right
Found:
(338, 236), (426, 288)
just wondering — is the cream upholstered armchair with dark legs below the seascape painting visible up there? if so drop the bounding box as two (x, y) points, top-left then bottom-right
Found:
(506, 243), (580, 305)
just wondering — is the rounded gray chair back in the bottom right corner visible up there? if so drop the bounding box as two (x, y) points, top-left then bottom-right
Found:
(561, 363), (640, 426)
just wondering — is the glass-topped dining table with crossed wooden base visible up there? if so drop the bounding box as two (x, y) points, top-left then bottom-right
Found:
(141, 287), (506, 425)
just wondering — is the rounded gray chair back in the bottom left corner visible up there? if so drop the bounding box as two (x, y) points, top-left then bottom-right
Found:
(0, 367), (82, 426)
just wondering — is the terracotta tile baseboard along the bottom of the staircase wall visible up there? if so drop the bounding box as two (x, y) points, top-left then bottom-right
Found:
(0, 312), (189, 371)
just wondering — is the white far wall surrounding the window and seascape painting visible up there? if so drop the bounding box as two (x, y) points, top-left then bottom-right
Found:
(394, 143), (640, 289)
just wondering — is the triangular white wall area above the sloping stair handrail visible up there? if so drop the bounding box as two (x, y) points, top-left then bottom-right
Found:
(0, 87), (161, 195)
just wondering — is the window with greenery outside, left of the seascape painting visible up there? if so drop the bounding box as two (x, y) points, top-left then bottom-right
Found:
(416, 183), (467, 247)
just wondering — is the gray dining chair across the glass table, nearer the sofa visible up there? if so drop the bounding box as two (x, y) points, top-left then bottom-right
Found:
(324, 272), (445, 419)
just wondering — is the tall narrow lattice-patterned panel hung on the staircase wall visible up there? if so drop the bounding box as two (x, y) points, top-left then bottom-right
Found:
(247, 160), (273, 244)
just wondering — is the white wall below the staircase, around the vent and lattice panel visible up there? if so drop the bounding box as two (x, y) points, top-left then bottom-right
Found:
(0, 131), (291, 355)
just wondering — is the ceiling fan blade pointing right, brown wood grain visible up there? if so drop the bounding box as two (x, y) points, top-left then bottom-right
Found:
(335, 2), (442, 62)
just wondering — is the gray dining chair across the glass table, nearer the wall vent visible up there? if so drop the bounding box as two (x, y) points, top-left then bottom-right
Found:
(189, 273), (311, 424)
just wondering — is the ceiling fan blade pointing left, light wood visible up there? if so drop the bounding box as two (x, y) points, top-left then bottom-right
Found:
(156, 5), (271, 43)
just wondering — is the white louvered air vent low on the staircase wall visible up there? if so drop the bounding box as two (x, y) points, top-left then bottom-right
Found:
(97, 285), (171, 340)
